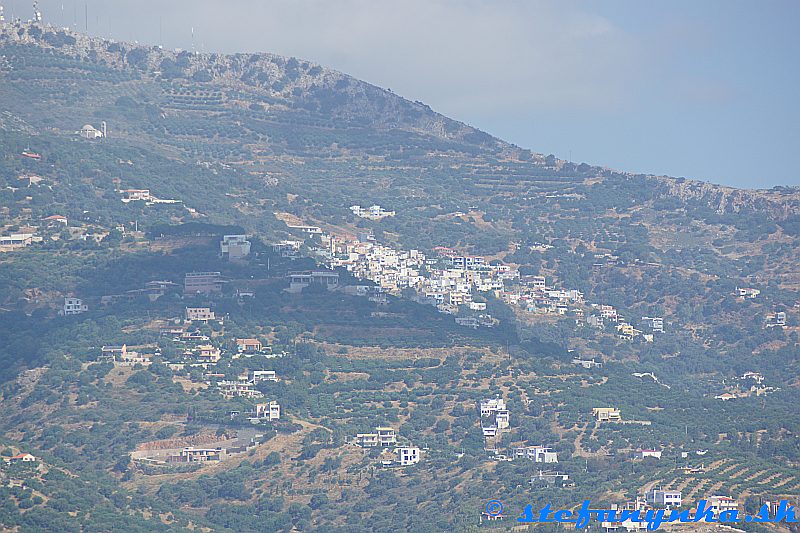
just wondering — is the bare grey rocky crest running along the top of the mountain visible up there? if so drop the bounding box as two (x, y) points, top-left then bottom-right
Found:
(0, 17), (800, 216)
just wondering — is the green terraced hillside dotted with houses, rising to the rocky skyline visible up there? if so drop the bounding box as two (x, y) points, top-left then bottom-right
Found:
(0, 11), (800, 533)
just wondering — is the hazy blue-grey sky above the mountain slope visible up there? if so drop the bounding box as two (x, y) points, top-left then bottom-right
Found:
(6, 0), (800, 187)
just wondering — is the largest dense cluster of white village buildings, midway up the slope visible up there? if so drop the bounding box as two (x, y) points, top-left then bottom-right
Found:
(282, 217), (664, 334)
